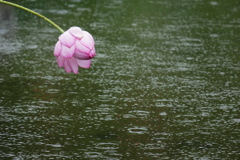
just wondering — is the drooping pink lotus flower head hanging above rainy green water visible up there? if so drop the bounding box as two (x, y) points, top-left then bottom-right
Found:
(54, 27), (96, 74)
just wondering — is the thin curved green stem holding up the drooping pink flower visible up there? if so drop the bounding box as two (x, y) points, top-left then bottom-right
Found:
(0, 0), (64, 33)
